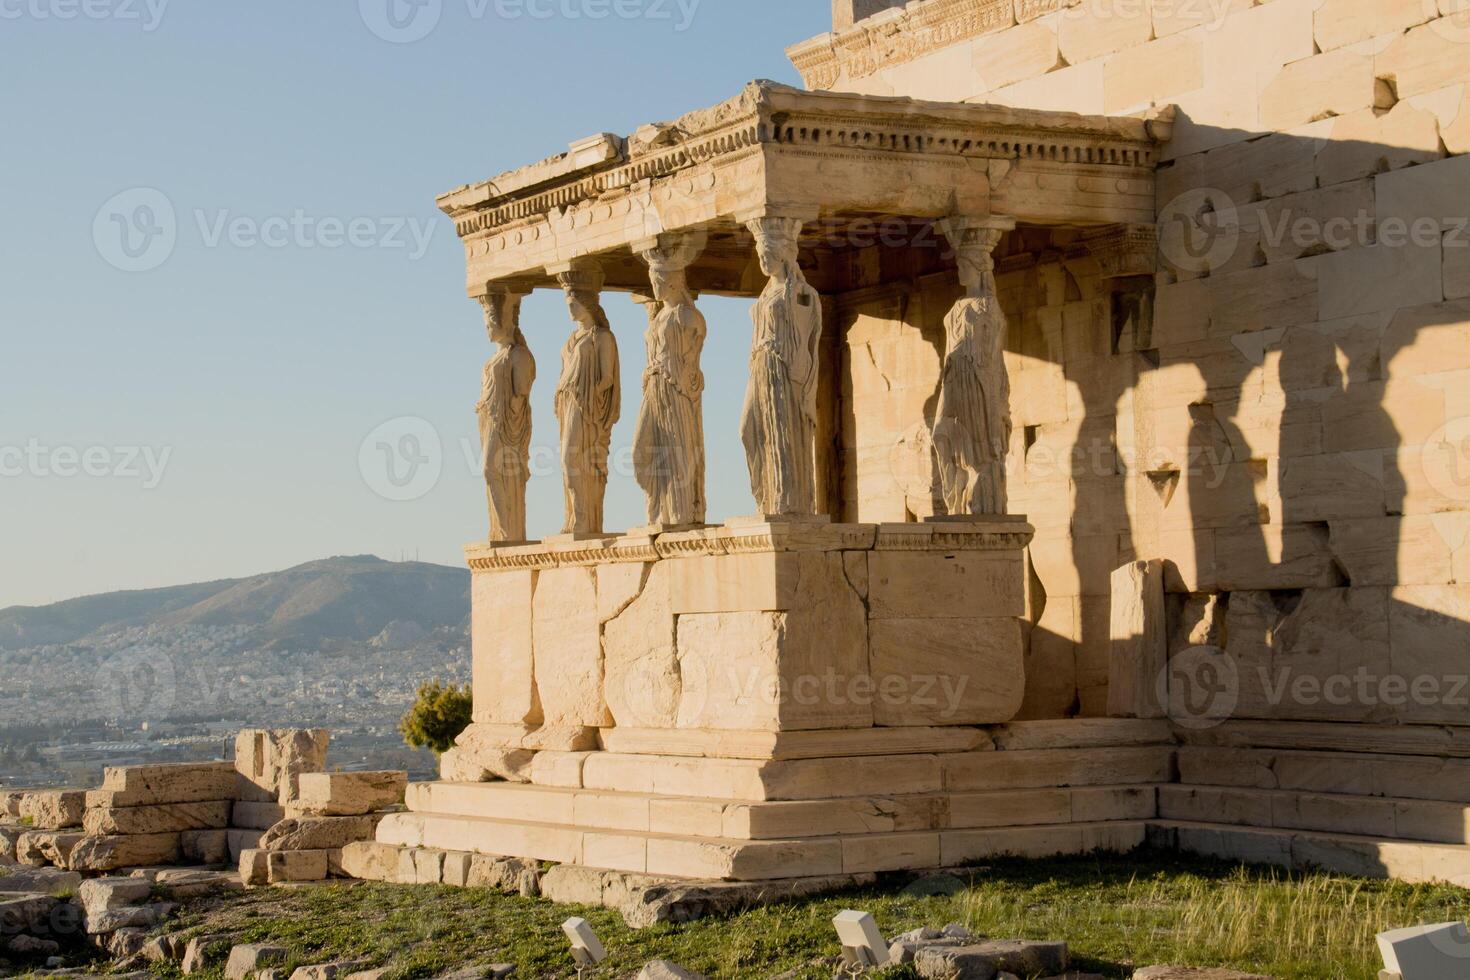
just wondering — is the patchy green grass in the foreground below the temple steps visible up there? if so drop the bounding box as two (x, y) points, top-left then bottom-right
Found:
(126, 852), (1470, 980)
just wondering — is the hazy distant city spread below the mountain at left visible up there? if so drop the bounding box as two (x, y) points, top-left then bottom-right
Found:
(0, 623), (470, 789)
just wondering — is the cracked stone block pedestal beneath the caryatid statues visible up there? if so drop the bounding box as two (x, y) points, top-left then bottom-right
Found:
(463, 520), (1032, 749)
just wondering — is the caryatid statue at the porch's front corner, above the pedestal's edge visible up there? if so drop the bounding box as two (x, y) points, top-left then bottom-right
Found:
(741, 217), (822, 516)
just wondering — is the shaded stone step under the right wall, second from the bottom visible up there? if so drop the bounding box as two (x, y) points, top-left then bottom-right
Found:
(1158, 786), (1470, 843)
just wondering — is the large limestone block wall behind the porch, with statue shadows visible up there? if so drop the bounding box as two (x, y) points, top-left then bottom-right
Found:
(811, 0), (1470, 724)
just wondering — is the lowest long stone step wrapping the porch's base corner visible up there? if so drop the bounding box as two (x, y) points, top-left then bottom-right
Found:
(378, 813), (1147, 882)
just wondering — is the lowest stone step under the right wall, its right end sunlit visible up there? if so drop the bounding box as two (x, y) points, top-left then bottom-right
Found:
(1148, 820), (1470, 887)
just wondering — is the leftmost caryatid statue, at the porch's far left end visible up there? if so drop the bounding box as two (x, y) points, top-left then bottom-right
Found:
(475, 289), (537, 542)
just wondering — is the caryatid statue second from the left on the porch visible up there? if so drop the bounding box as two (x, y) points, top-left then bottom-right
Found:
(556, 264), (622, 535)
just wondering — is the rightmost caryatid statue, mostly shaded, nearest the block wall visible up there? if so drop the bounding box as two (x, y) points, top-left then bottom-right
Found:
(933, 217), (1016, 517)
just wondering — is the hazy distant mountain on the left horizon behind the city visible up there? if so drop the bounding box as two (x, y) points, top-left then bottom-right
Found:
(0, 555), (469, 649)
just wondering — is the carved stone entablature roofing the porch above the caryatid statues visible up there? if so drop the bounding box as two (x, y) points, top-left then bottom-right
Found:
(440, 82), (1158, 295)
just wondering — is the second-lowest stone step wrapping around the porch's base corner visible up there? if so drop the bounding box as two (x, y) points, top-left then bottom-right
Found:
(407, 783), (1157, 840)
